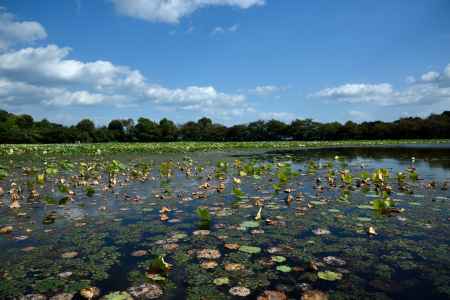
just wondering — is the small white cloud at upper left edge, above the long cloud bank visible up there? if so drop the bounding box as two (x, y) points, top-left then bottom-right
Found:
(0, 7), (47, 50)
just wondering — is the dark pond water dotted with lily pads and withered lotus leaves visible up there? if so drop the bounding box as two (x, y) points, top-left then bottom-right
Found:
(0, 145), (450, 299)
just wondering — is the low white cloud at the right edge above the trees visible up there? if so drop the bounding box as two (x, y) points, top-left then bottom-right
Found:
(310, 65), (450, 106)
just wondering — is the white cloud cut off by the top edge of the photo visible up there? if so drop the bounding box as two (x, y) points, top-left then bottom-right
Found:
(111, 0), (265, 23)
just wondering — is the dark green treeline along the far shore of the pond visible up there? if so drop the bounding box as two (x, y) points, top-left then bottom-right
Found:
(0, 110), (450, 144)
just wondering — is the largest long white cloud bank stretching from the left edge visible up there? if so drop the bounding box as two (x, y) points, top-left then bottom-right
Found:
(0, 45), (250, 116)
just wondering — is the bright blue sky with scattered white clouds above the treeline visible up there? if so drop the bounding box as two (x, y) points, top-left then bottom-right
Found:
(0, 0), (450, 125)
